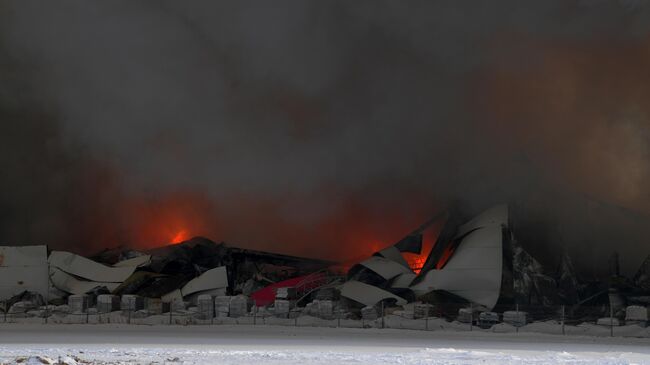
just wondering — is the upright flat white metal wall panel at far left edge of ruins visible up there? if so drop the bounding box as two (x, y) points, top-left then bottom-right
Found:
(0, 246), (49, 300)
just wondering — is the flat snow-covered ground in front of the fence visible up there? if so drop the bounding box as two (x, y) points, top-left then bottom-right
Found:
(0, 324), (650, 365)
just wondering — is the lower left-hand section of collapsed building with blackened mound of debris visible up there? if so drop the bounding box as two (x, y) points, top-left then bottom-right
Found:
(0, 237), (332, 310)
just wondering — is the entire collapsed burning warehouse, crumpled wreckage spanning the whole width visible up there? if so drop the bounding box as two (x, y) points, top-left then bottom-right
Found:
(0, 204), (650, 323)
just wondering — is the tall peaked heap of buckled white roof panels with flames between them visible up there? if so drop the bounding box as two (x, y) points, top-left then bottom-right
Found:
(341, 205), (509, 309)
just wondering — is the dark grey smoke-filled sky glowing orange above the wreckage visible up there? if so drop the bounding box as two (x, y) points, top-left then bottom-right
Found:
(0, 0), (650, 270)
